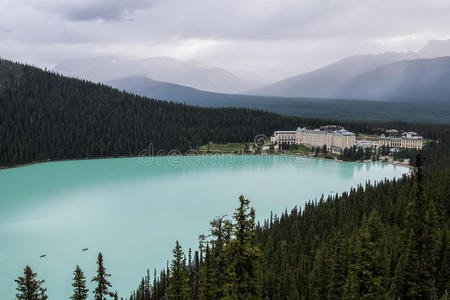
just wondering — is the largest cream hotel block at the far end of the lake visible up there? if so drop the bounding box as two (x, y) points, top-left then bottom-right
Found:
(270, 127), (355, 152)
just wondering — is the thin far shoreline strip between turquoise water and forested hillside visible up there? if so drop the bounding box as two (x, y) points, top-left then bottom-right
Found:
(0, 153), (414, 171)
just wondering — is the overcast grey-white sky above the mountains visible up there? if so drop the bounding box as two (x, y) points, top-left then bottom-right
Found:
(0, 0), (450, 79)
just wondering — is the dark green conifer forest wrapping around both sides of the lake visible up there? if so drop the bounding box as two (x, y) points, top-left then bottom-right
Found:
(0, 60), (450, 300)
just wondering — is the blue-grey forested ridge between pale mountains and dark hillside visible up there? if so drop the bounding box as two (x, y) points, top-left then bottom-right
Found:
(107, 77), (450, 124)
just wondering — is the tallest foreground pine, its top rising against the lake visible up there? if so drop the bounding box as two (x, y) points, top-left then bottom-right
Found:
(225, 196), (261, 300)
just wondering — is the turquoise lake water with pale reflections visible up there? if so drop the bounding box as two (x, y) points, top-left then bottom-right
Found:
(0, 156), (408, 300)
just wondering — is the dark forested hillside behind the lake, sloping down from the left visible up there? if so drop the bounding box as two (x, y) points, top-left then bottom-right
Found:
(0, 60), (448, 166)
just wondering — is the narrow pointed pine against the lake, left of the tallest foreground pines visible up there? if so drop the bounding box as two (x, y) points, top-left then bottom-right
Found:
(168, 241), (189, 300)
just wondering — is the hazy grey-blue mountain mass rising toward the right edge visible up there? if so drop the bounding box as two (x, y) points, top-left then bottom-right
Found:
(248, 40), (450, 101)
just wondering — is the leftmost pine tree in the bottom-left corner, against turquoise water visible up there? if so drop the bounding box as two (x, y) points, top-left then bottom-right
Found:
(14, 266), (48, 300)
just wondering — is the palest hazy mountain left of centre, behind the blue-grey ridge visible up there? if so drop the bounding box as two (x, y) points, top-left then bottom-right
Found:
(55, 56), (261, 93)
